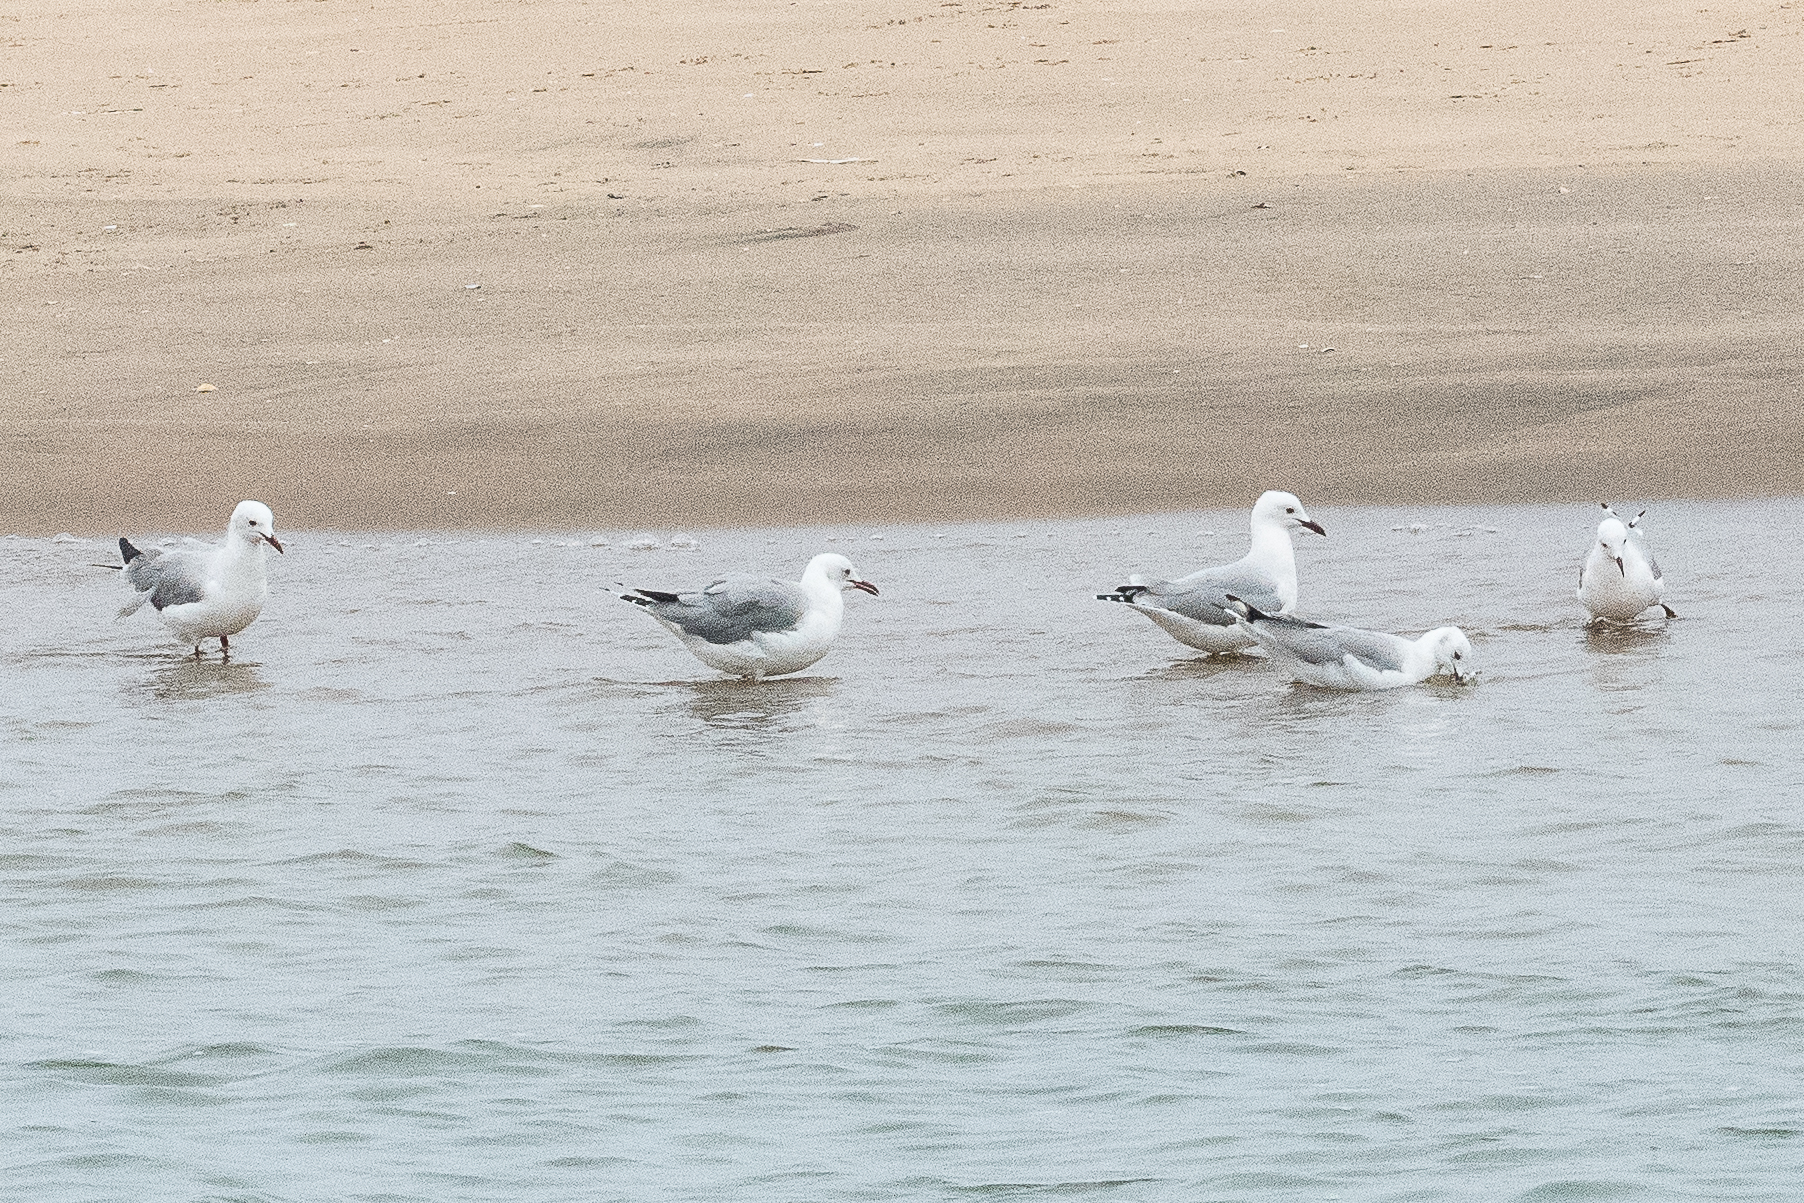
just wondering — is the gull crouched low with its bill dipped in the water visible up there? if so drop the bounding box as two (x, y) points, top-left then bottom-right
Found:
(1227, 597), (1472, 689)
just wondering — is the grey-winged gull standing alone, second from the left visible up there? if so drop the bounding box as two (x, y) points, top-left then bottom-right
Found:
(621, 552), (877, 680)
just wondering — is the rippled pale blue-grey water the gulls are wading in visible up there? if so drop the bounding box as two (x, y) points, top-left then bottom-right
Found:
(0, 501), (1804, 1203)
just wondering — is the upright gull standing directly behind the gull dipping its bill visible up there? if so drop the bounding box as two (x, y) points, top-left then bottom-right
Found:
(1097, 489), (1328, 653)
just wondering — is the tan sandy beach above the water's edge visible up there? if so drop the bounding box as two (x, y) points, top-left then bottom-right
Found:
(0, 0), (1804, 532)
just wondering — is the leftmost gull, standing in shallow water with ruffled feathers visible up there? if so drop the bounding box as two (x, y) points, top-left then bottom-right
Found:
(119, 501), (281, 657)
